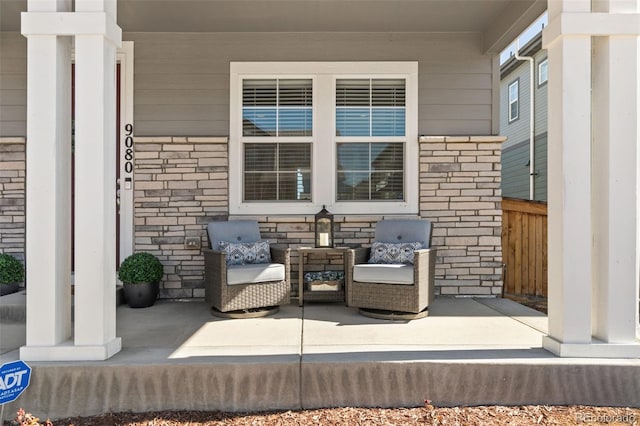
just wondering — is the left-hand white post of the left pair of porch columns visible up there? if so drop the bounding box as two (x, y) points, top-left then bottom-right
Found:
(20, 1), (71, 360)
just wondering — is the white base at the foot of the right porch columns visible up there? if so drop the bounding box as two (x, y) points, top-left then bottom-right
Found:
(542, 336), (640, 358)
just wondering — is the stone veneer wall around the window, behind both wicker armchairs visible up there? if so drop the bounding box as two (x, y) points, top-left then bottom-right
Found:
(134, 136), (504, 298)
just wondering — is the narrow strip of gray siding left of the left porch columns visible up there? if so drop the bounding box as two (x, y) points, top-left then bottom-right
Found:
(0, 32), (27, 137)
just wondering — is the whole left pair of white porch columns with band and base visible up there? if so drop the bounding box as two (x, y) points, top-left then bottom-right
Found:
(20, 0), (122, 361)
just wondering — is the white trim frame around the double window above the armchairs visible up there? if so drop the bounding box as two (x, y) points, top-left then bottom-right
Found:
(229, 62), (419, 215)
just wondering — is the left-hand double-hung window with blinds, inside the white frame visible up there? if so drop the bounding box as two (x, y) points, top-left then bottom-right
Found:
(242, 78), (313, 202)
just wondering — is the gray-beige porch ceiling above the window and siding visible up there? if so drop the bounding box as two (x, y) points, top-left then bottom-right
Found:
(0, 0), (546, 53)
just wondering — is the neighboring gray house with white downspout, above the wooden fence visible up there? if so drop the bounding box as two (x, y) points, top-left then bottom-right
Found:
(500, 33), (548, 201)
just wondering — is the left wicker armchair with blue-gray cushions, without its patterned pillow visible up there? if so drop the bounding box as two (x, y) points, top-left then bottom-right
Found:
(203, 220), (291, 318)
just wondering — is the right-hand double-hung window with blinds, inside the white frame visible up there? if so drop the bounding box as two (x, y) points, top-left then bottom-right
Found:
(336, 78), (406, 201)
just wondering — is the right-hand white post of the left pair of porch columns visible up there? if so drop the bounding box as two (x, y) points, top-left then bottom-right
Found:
(74, 0), (121, 359)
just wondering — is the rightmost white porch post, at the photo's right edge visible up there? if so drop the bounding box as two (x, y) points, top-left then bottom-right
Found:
(592, 0), (640, 346)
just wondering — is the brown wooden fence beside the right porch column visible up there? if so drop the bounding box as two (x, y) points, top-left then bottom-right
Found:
(502, 198), (547, 298)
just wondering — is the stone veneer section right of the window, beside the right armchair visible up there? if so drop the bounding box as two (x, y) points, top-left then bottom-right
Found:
(419, 136), (505, 295)
